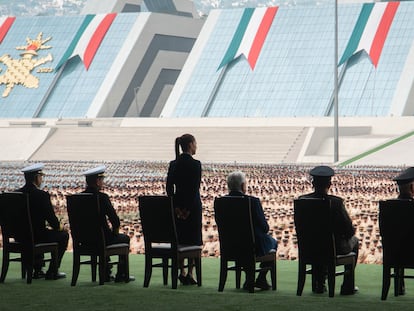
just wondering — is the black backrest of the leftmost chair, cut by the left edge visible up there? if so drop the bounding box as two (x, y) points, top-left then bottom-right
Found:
(0, 192), (34, 249)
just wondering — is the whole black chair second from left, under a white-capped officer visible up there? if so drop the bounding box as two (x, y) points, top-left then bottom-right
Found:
(66, 193), (129, 286)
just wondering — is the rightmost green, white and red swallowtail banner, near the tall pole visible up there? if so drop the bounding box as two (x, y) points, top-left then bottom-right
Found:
(338, 2), (400, 67)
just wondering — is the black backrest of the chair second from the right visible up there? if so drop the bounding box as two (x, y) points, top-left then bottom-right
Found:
(294, 198), (336, 264)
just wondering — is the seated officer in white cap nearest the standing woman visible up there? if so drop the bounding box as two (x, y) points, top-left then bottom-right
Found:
(79, 165), (135, 282)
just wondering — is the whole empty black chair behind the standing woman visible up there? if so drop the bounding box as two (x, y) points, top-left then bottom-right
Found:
(138, 196), (202, 289)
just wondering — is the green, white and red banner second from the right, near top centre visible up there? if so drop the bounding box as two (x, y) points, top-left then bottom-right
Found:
(218, 7), (278, 70)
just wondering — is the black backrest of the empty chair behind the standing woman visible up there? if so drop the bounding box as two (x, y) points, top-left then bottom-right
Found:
(138, 195), (178, 251)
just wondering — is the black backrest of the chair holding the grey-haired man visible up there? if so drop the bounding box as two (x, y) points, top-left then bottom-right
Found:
(214, 196), (255, 261)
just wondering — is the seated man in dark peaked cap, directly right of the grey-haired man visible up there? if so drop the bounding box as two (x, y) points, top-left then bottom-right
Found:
(299, 166), (359, 295)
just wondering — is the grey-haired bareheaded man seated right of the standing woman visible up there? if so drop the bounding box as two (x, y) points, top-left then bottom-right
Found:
(227, 171), (277, 290)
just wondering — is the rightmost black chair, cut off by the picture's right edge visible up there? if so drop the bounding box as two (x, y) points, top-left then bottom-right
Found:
(379, 199), (414, 300)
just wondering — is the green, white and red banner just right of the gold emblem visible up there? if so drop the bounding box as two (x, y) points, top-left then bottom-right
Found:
(55, 13), (116, 70)
